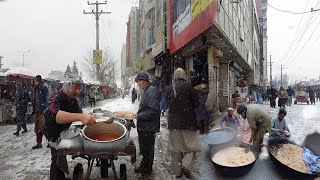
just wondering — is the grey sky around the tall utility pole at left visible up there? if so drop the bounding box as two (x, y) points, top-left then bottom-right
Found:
(0, 0), (131, 81)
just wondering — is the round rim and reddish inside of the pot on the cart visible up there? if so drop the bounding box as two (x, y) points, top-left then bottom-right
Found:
(82, 121), (128, 143)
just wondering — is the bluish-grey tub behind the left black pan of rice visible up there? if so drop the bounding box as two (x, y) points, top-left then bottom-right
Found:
(201, 127), (237, 154)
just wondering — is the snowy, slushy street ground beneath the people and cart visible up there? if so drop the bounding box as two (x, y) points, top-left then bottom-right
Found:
(0, 97), (320, 180)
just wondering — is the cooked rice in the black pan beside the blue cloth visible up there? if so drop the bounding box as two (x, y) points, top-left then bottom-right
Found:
(272, 144), (308, 173)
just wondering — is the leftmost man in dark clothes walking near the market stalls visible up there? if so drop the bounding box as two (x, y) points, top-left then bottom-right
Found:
(13, 82), (30, 136)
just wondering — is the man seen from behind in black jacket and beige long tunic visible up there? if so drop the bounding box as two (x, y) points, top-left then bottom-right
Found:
(168, 68), (200, 179)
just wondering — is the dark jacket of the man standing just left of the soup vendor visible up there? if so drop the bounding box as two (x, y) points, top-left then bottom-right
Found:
(33, 84), (49, 113)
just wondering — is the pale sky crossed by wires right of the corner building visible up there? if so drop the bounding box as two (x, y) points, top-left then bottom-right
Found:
(268, 0), (320, 80)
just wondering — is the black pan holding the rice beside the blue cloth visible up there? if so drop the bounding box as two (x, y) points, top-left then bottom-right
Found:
(268, 139), (317, 179)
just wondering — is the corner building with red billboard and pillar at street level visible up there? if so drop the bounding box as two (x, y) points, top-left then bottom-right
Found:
(167, 0), (261, 111)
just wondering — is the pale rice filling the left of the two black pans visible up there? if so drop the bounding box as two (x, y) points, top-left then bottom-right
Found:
(212, 147), (256, 167)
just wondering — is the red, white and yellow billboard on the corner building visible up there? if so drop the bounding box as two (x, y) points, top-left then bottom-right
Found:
(170, 0), (218, 54)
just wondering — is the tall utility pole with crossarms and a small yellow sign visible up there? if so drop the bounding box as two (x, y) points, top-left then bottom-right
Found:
(83, 1), (111, 80)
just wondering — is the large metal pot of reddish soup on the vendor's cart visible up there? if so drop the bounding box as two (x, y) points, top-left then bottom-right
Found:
(82, 118), (130, 153)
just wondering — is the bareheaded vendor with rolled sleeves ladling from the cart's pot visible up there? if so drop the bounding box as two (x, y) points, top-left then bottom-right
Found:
(44, 77), (95, 180)
